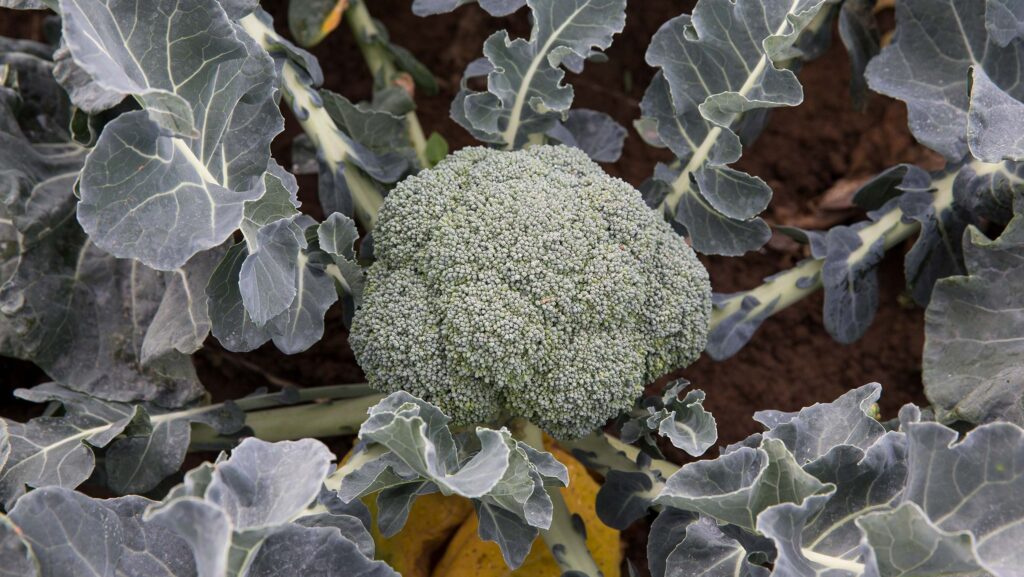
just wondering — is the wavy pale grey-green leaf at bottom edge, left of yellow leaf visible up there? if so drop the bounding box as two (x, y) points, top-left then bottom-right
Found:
(137, 439), (397, 577)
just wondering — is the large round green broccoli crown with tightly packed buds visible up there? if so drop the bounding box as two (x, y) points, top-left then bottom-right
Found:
(349, 146), (711, 439)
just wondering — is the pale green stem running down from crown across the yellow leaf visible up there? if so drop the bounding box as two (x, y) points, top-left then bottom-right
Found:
(511, 419), (602, 577)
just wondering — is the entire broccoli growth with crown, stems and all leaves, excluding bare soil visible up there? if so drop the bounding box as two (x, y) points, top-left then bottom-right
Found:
(0, 0), (1024, 577)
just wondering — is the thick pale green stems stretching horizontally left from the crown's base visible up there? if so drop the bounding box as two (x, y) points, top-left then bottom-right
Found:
(187, 384), (383, 451)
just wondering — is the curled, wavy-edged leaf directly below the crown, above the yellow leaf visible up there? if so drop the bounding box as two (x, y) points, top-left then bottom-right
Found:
(338, 391), (568, 568)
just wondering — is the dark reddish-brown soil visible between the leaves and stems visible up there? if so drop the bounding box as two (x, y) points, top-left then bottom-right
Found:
(0, 0), (941, 573)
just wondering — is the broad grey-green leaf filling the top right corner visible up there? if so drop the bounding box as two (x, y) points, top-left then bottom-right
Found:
(867, 0), (1024, 162)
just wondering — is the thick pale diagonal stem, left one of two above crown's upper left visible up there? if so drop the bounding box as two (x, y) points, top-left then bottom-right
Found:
(239, 14), (384, 231)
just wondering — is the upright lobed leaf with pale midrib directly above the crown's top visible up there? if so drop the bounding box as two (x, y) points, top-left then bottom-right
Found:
(452, 0), (626, 149)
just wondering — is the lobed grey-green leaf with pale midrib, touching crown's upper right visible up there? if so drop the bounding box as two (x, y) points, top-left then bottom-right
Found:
(638, 0), (827, 255)
